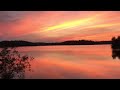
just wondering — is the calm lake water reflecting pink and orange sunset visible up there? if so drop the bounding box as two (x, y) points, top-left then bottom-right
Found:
(2, 45), (120, 79)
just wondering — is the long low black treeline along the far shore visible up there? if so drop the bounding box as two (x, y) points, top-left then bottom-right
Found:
(0, 40), (111, 47)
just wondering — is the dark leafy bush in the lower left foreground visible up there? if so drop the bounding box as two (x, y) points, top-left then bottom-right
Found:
(0, 47), (33, 79)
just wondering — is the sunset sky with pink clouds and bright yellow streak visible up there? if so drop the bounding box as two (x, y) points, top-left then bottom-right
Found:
(0, 11), (120, 42)
